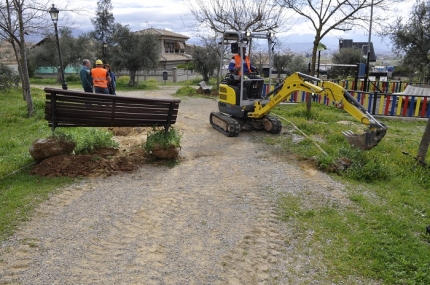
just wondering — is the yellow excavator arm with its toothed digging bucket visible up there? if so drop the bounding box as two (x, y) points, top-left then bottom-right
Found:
(248, 72), (388, 150)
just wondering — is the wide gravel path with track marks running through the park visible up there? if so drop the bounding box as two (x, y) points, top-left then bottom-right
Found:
(0, 87), (359, 285)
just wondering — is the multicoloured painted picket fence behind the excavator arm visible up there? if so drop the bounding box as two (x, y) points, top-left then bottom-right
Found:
(263, 84), (430, 118)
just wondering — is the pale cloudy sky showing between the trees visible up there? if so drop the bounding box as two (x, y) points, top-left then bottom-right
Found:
(62, 0), (414, 53)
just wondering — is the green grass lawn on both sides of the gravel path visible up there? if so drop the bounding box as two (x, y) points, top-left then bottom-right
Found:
(0, 80), (430, 284)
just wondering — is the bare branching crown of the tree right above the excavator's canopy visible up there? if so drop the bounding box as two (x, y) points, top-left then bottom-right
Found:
(187, 0), (286, 33)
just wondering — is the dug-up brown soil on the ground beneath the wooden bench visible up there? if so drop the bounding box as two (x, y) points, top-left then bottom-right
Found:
(31, 128), (154, 177)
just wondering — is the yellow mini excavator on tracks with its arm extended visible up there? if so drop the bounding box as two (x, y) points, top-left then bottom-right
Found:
(209, 31), (388, 150)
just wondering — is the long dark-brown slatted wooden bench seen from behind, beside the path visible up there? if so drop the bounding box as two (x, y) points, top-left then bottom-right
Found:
(44, 87), (181, 133)
